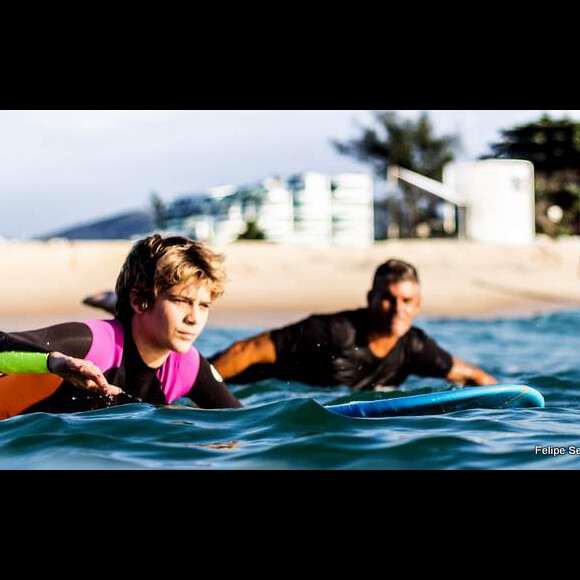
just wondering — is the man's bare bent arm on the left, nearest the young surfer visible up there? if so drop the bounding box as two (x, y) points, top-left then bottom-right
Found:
(212, 332), (276, 381)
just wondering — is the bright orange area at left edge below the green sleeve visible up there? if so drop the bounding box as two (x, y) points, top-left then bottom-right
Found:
(0, 375), (62, 421)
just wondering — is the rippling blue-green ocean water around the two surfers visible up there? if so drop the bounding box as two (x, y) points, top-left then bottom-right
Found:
(0, 311), (580, 470)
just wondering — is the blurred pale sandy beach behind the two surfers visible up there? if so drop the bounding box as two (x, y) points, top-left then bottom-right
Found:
(0, 239), (580, 330)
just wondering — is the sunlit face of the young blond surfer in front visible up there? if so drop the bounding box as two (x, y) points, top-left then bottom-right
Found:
(143, 280), (211, 354)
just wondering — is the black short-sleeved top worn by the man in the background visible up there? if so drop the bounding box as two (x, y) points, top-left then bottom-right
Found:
(216, 309), (453, 391)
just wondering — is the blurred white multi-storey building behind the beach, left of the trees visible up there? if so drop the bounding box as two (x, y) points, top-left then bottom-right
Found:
(162, 172), (374, 245)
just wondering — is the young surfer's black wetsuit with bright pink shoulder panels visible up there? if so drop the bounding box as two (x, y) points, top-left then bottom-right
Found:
(0, 320), (241, 413)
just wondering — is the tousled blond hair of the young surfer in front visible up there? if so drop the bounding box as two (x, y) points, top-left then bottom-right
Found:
(115, 234), (226, 322)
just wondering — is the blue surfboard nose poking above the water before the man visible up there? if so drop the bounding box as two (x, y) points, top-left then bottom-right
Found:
(326, 385), (545, 419)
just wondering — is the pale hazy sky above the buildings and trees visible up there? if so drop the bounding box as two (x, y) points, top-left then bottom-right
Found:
(0, 110), (580, 238)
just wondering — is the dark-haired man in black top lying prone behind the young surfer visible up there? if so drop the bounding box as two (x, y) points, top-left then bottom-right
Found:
(87, 260), (497, 391)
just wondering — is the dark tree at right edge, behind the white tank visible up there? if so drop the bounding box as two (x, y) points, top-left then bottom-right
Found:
(482, 115), (580, 236)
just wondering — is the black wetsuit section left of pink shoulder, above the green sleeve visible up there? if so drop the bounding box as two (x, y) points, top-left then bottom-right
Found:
(0, 322), (93, 359)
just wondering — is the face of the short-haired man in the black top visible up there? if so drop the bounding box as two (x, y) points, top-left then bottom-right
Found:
(369, 280), (421, 338)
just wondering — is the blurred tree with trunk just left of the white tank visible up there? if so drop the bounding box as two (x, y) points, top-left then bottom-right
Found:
(333, 111), (460, 237)
